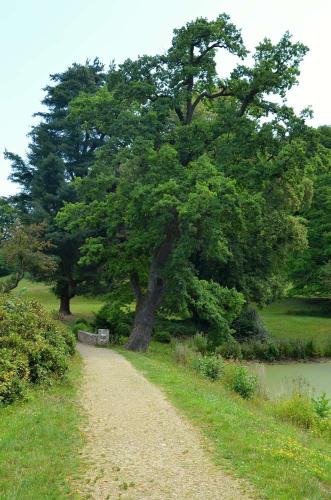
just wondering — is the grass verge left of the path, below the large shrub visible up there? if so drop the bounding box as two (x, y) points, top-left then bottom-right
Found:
(0, 356), (82, 500)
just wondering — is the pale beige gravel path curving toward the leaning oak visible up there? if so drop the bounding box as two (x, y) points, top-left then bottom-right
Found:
(78, 344), (250, 500)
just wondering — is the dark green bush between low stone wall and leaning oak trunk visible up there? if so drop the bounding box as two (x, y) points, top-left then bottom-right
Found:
(93, 300), (133, 344)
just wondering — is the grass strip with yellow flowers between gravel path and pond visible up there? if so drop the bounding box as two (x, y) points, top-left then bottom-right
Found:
(120, 344), (331, 500)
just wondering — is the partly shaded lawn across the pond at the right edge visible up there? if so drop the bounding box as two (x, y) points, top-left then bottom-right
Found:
(260, 298), (331, 345)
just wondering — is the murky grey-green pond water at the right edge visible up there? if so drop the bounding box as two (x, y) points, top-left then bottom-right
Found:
(252, 361), (331, 399)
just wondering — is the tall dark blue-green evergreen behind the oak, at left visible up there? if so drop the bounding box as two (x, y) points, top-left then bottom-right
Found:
(6, 59), (105, 315)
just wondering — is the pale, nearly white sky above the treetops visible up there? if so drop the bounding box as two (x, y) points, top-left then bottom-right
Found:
(0, 0), (331, 195)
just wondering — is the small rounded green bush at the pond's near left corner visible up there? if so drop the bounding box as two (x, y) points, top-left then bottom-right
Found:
(224, 364), (258, 399)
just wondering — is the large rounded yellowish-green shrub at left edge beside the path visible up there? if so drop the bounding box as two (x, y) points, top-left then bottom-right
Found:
(0, 295), (75, 403)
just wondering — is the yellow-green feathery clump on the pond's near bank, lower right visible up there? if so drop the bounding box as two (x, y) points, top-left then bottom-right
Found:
(274, 394), (317, 429)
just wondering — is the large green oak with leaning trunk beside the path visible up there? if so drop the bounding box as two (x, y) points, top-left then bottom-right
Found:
(58, 14), (314, 350)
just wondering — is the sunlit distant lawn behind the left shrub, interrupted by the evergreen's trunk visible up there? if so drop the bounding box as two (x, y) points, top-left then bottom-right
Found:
(13, 279), (102, 318)
